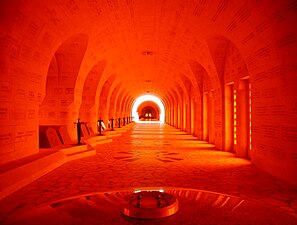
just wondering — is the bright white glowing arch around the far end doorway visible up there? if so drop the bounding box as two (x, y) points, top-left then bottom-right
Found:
(132, 95), (165, 123)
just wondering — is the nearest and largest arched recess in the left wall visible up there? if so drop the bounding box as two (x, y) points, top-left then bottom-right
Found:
(39, 33), (88, 126)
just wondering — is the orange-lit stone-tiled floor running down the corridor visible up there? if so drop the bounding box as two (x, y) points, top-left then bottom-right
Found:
(0, 124), (297, 224)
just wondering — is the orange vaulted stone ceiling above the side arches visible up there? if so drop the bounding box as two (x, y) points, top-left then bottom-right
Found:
(0, 0), (296, 102)
